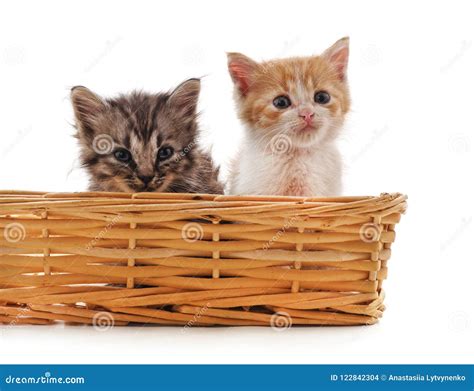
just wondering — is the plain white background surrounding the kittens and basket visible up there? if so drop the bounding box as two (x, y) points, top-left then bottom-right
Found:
(0, 0), (474, 363)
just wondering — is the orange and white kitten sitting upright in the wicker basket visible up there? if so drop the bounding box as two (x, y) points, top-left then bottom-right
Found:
(228, 38), (350, 196)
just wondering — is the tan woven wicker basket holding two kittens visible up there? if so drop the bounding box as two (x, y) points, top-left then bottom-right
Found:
(0, 192), (406, 328)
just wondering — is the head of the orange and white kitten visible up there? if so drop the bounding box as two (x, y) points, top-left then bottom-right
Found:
(228, 38), (349, 147)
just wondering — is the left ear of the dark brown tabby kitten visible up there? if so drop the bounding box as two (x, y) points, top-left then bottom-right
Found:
(71, 86), (106, 136)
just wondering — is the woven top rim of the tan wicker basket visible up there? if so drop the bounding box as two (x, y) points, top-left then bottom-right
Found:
(0, 191), (408, 220)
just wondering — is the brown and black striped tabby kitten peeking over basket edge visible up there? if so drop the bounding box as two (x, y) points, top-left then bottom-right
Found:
(71, 79), (223, 194)
